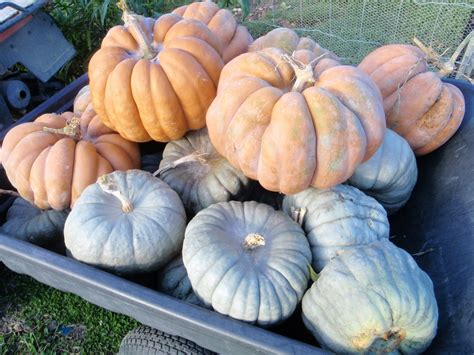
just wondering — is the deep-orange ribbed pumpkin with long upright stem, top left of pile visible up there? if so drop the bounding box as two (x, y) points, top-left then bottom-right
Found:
(89, 3), (224, 142)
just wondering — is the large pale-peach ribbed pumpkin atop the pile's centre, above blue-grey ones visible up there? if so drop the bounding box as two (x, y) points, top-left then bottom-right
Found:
(206, 48), (385, 194)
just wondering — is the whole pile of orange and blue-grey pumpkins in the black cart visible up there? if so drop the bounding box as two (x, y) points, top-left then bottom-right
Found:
(1, 1), (464, 353)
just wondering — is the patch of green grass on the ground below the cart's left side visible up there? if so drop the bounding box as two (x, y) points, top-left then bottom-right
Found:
(0, 265), (139, 355)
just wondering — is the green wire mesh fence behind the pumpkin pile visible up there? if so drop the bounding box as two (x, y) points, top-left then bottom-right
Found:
(245, 0), (474, 80)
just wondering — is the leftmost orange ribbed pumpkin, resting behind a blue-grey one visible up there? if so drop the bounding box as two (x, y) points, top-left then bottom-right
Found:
(1, 109), (140, 210)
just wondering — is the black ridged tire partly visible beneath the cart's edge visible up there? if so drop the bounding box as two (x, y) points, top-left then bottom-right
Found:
(119, 326), (215, 355)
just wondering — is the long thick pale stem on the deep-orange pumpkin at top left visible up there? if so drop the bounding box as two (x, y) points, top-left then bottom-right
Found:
(117, 0), (156, 59)
